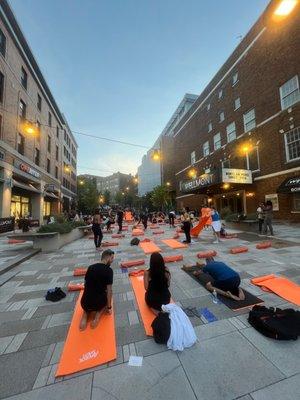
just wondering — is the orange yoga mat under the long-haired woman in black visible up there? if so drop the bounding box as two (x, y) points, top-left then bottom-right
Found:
(129, 271), (155, 336)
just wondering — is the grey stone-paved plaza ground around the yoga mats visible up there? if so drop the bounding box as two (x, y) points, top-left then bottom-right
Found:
(0, 225), (300, 400)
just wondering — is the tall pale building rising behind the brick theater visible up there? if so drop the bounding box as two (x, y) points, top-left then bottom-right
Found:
(137, 93), (198, 196)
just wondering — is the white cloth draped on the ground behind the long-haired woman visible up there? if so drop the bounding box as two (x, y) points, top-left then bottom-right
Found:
(161, 303), (197, 351)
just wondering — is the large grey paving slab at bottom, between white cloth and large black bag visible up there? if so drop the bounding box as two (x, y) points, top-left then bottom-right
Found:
(179, 332), (284, 400)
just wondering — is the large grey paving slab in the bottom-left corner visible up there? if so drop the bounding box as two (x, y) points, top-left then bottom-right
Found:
(0, 347), (47, 398)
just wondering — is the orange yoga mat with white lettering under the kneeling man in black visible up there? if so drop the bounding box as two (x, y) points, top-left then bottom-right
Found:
(55, 291), (117, 377)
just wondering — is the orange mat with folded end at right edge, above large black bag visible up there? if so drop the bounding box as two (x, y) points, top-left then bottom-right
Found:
(251, 274), (300, 306)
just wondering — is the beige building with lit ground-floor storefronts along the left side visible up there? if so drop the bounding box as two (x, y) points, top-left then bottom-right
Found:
(0, 0), (77, 223)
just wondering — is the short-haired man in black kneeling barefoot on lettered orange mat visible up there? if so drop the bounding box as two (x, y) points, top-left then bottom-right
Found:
(79, 249), (115, 331)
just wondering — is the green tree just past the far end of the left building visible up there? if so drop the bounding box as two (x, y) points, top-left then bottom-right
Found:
(77, 179), (99, 214)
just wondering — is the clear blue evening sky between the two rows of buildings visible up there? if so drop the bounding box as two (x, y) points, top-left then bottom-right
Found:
(10, 0), (269, 176)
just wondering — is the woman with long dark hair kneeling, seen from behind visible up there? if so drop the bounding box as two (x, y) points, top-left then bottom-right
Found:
(144, 252), (171, 315)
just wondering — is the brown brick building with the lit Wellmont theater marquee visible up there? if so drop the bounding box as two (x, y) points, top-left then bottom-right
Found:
(174, 1), (300, 221)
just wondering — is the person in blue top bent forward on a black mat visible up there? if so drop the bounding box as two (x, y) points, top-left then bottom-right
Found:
(194, 257), (245, 300)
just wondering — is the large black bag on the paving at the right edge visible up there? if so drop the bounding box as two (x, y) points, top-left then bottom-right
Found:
(248, 306), (300, 340)
